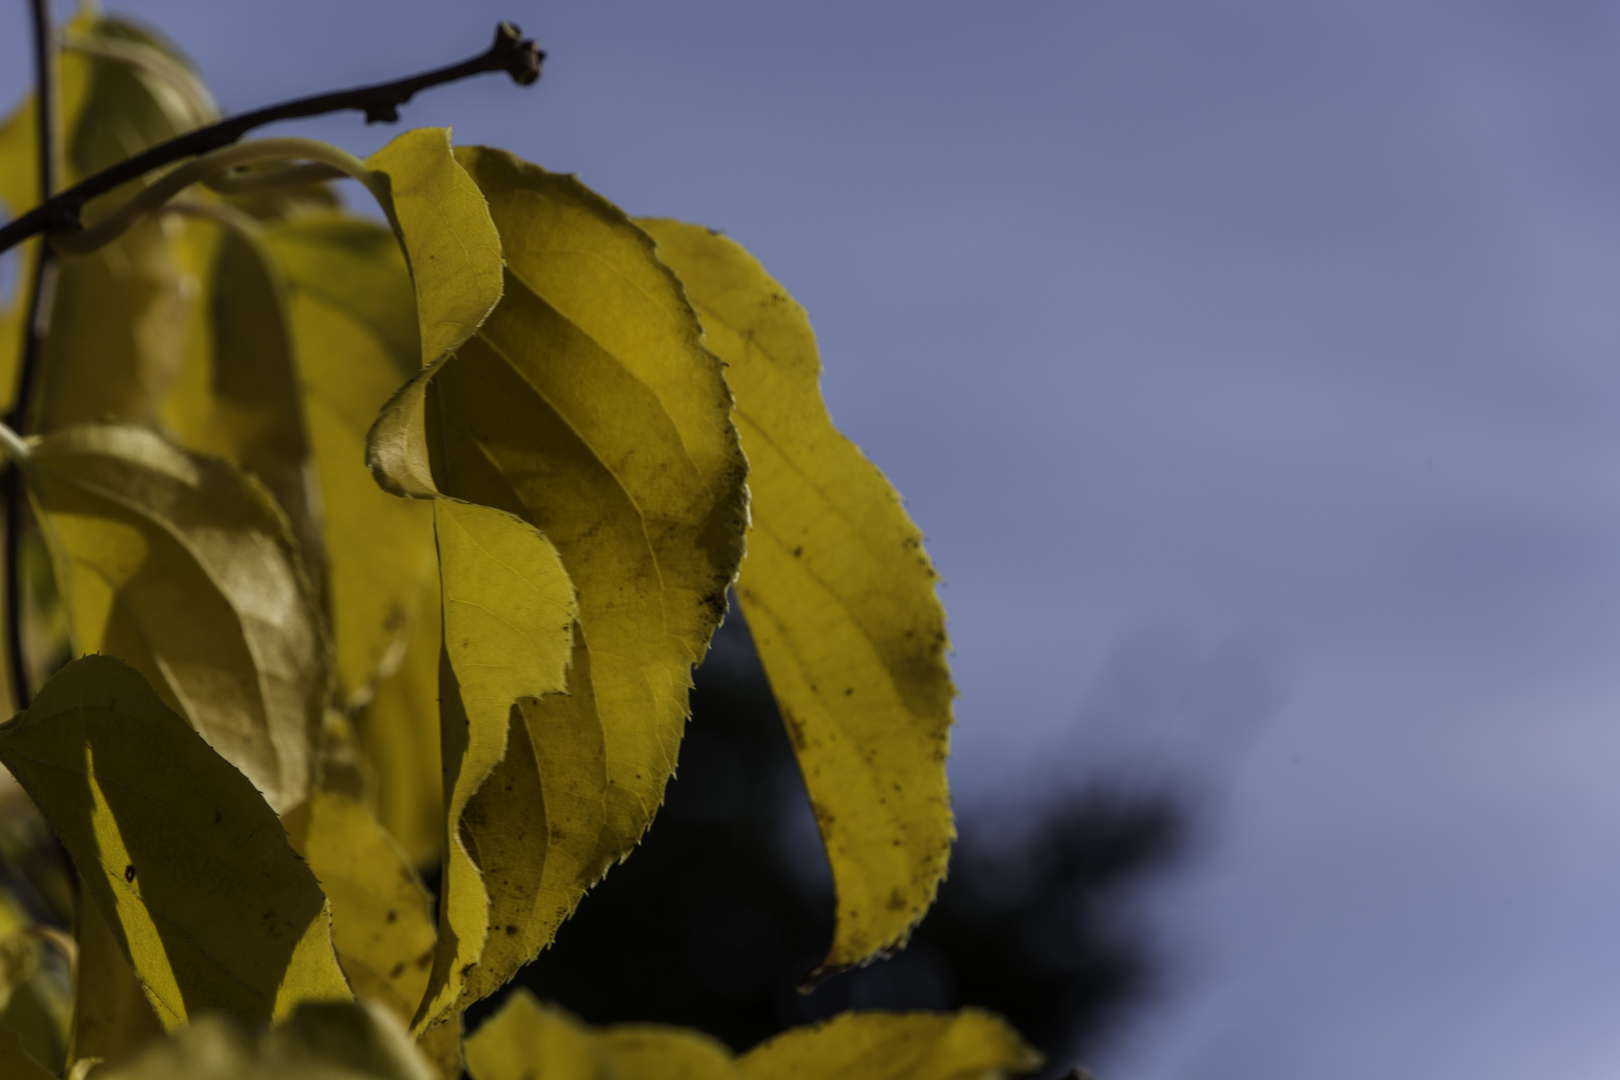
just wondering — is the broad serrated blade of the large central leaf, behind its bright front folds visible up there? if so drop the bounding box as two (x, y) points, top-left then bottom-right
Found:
(368, 149), (747, 1007)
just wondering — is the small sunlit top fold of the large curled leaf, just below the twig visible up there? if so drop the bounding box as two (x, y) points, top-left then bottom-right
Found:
(366, 128), (501, 364)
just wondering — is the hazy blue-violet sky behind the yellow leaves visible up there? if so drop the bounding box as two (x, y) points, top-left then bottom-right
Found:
(0, 0), (1620, 1080)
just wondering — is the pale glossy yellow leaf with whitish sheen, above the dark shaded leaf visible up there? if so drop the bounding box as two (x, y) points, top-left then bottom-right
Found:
(24, 424), (330, 810)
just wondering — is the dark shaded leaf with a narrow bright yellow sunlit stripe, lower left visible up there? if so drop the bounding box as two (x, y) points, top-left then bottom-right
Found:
(0, 656), (350, 1030)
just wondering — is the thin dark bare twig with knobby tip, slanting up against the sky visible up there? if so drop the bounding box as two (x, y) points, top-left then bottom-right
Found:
(0, 22), (546, 259)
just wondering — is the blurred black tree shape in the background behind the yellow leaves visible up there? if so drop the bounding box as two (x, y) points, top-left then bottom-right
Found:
(467, 620), (1186, 1067)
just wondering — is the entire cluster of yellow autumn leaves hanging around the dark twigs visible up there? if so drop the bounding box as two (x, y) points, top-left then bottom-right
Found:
(0, 11), (1037, 1080)
